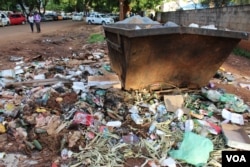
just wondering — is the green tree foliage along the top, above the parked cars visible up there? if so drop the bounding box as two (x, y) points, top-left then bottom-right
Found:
(0, 0), (250, 13)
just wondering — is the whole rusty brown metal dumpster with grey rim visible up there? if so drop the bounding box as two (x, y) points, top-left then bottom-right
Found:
(103, 24), (248, 90)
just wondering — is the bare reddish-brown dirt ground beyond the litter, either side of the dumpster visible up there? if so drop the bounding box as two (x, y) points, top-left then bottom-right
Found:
(0, 23), (250, 166)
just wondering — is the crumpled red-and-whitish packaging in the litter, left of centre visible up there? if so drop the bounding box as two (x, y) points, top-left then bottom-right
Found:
(73, 111), (94, 126)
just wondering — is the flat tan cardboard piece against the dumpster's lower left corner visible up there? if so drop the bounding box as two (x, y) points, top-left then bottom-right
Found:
(88, 74), (121, 88)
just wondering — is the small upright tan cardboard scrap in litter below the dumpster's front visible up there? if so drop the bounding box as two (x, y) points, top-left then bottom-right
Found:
(164, 95), (184, 112)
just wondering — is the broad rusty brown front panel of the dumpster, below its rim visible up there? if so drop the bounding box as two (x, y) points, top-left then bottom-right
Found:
(122, 34), (240, 89)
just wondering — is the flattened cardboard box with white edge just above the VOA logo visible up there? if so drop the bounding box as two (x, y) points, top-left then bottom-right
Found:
(221, 124), (250, 151)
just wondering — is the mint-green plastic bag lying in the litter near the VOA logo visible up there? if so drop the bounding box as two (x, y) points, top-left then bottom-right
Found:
(169, 132), (213, 166)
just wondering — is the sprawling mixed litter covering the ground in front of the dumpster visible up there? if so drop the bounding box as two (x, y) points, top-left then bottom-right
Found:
(0, 15), (250, 167)
